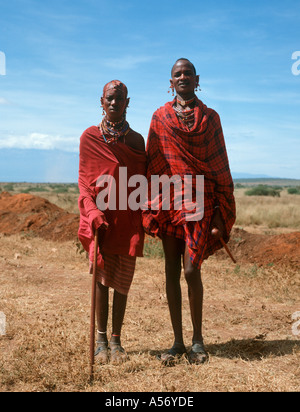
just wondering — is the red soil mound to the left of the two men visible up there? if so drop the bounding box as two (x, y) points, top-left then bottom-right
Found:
(0, 192), (79, 241)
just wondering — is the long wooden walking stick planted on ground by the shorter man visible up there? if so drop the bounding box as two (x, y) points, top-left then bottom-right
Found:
(90, 230), (99, 381)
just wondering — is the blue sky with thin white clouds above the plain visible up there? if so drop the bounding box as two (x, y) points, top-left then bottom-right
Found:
(0, 0), (300, 181)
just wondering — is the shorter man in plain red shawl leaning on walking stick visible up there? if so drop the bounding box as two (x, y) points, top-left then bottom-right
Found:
(78, 80), (146, 363)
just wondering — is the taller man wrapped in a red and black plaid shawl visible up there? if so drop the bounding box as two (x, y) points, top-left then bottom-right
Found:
(143, 59), (235, 364)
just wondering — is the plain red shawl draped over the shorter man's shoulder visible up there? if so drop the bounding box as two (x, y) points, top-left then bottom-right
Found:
(78, 126), (146, 267)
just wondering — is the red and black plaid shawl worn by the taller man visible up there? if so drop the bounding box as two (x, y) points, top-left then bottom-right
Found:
(143, 99), (236, 267)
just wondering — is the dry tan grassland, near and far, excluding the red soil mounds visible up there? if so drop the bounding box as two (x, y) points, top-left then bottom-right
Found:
(0, 180), (300, 393)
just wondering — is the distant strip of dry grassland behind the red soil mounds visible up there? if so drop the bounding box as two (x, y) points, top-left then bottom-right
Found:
(0, 179), (300, 230)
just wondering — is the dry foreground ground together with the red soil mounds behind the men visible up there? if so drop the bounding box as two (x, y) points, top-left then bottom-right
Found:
(0, 193), (300, 392)
